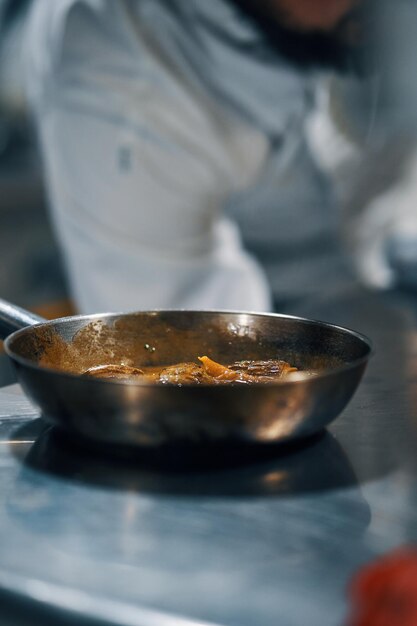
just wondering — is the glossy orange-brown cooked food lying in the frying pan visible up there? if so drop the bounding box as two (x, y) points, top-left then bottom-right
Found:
(83, 356), (297, 385)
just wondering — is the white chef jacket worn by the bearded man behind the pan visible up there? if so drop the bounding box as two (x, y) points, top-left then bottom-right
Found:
(26, 0), (352, 313)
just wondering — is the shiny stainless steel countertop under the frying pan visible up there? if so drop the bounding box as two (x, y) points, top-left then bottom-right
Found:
(0, 292), (417, 626)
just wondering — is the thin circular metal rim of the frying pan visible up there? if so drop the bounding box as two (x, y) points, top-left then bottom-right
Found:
(4, 308), (375, 390)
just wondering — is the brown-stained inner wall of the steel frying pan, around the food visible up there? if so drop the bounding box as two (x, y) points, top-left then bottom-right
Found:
(8, 311), (370, 374)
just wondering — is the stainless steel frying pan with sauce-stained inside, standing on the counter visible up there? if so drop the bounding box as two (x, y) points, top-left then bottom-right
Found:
(0, 300), (372, 446)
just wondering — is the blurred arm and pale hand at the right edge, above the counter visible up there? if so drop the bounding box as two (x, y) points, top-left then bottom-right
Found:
(310, 78), (417, 289)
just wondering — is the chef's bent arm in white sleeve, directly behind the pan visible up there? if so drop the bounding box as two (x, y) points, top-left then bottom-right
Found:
(27, 2), (270, 312)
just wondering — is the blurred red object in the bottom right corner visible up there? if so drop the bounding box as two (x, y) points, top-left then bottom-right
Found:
(346, 547), (417, 626)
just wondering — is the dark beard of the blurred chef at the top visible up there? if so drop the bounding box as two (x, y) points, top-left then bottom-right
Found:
(231, 0), (373, 75)
